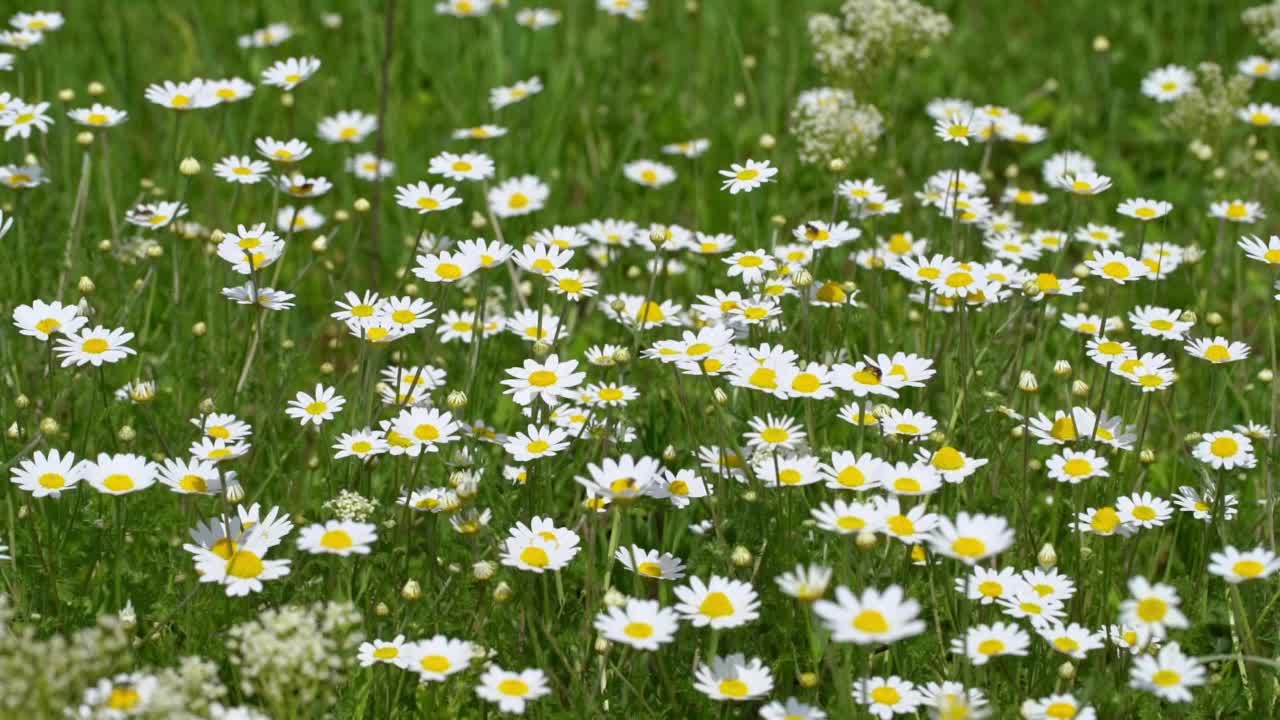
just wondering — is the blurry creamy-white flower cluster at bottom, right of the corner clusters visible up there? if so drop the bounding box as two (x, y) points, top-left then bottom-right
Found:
(227, 602), (364, 717)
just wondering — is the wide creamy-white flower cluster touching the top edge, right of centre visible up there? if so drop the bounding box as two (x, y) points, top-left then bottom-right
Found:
(809, 0), (951, 86)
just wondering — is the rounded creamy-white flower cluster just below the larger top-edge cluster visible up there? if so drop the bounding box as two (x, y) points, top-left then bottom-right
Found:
(790, 87), (884, 164)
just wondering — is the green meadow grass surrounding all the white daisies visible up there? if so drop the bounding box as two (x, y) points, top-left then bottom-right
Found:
(0, 0), (1280, 717)
